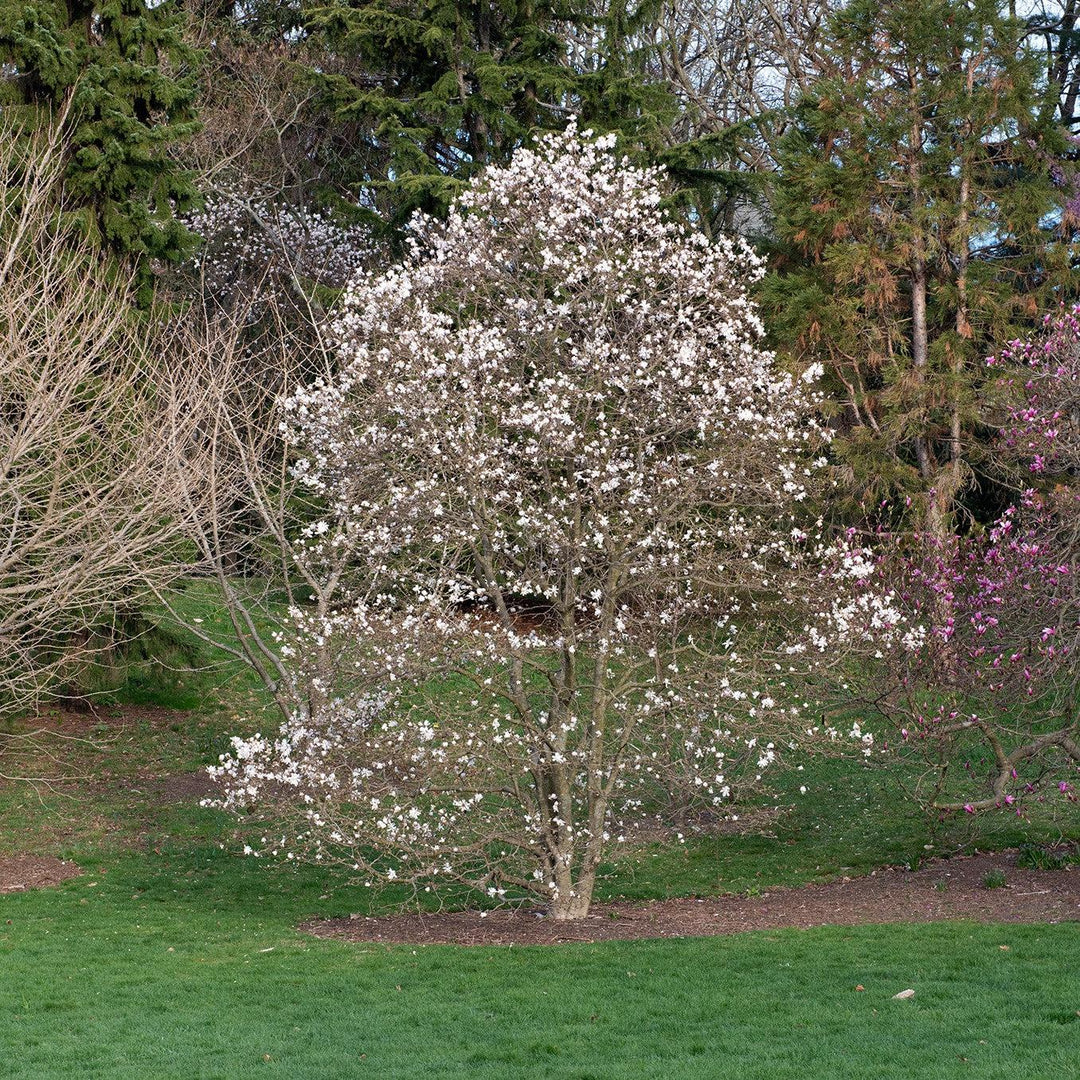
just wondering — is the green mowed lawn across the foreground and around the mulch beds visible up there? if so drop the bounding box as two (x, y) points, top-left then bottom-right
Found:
(6, 590), (1080, 1080)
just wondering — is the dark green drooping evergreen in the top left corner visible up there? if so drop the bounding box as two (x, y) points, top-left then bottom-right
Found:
(0, 0), (197, 278)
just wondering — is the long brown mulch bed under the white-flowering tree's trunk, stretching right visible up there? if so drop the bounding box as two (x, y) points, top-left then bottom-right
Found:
(300, 852), (1080, 945)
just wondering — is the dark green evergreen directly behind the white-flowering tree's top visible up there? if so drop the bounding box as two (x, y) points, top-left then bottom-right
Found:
(306, 0), (677, 225)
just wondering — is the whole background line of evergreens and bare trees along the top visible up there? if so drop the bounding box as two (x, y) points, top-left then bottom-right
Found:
(0, 0), (1080, 673)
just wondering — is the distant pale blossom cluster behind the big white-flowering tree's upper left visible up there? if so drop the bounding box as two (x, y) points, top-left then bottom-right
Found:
(184, 184), (376, 307)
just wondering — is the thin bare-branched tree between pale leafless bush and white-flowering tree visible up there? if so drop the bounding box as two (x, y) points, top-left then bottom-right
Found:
(147, 296), (351, 718)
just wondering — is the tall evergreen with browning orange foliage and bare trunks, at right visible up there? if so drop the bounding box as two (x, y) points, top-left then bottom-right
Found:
(765, 0), (1076, 532)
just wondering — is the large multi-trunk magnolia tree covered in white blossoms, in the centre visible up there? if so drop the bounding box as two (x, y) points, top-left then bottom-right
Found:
(216, 130), (823, 919)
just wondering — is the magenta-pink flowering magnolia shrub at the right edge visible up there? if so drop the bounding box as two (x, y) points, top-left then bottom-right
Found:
(812, 309), (1080, 813)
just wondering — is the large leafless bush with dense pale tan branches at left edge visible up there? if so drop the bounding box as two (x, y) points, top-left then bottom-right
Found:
(0, 125), (214, 718)
